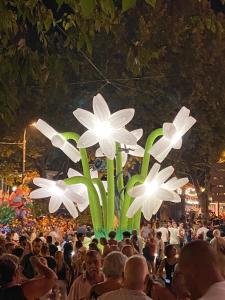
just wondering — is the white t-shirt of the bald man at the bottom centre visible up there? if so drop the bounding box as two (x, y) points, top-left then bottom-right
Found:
(99, 288), (151, 300)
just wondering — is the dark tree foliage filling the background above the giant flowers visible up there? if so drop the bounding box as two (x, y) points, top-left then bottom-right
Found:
(0, 0), (225, 213)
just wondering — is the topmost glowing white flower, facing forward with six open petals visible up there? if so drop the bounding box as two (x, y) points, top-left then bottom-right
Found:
(73, 94), (137, 159)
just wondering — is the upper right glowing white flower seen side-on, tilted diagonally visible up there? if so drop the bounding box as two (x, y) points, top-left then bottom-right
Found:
(150, 106), (196, 162)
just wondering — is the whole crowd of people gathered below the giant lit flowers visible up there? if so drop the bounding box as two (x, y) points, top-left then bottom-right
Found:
(0, 219), (225, 300)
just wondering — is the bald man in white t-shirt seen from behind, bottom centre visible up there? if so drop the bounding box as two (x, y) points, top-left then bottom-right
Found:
(99, 255), (151, 300)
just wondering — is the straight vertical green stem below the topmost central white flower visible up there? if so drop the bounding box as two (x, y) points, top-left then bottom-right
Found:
(107, 159), (115, 231)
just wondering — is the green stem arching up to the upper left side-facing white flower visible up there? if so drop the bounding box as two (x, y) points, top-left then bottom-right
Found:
(63, 132), (102, 227)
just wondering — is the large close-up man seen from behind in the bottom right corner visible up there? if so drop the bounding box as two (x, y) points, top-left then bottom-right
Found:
(179, 240), (225, 300)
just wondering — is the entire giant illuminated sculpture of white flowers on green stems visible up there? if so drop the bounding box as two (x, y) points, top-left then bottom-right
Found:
(30, 94), (196, 238)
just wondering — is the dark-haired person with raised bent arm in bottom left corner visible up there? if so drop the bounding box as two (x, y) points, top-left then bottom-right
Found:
(0, 256), (56, 300)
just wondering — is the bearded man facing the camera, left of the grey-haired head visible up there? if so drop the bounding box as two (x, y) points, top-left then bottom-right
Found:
(68, 250), (104, 300)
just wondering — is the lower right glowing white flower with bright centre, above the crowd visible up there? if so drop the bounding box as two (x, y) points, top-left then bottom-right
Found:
(127, 163), (188, 220)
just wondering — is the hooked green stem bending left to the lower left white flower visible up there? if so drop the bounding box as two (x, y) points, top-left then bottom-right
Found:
(64, 176), (102, 231)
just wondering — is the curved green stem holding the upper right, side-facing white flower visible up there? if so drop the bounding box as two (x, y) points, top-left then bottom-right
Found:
(132, 128), (163, 230)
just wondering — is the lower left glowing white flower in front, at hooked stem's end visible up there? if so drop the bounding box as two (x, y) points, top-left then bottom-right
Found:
(30, 178), (88, 218)
